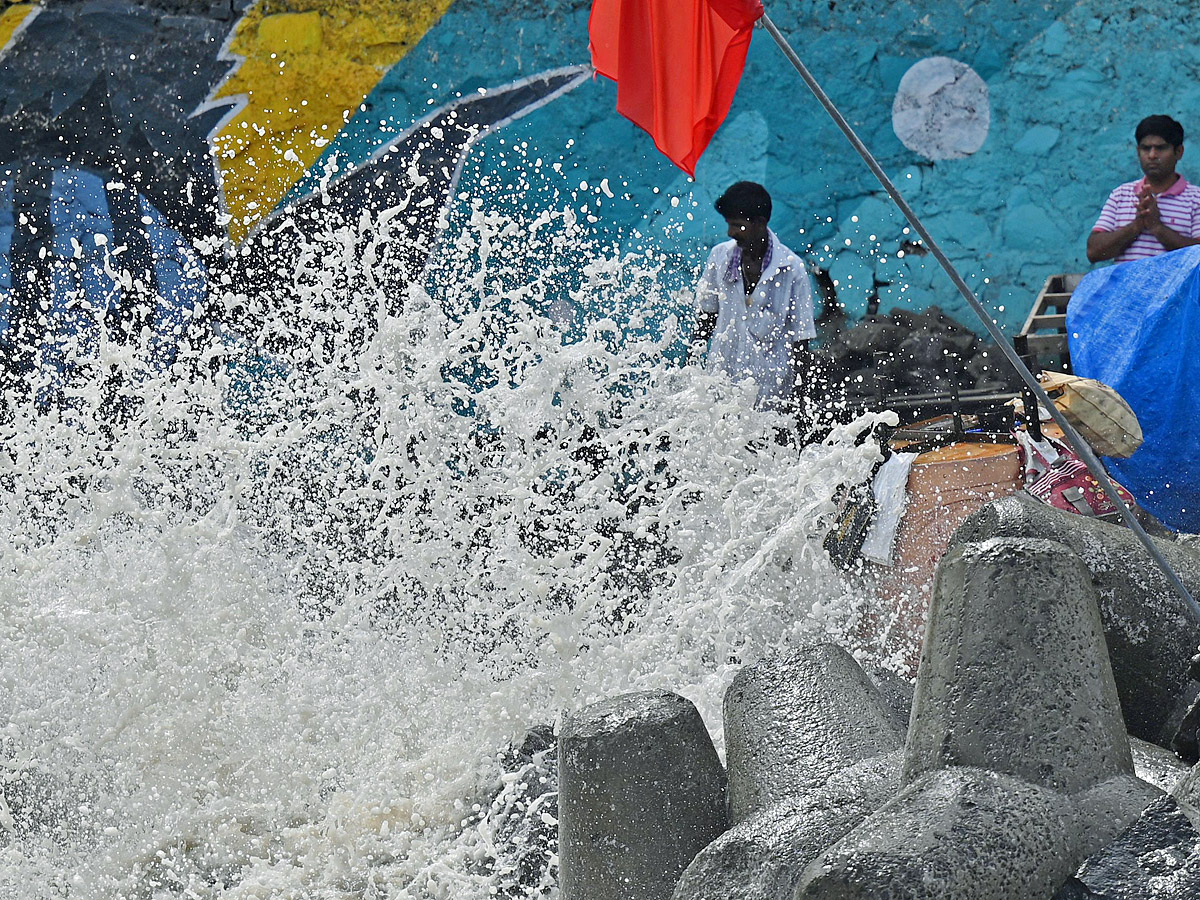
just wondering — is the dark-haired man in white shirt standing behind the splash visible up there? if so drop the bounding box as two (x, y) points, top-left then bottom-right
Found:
(692, 181), (816, 408)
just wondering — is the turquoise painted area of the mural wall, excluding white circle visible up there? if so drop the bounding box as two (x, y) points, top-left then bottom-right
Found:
(316, 0), (1200, 331)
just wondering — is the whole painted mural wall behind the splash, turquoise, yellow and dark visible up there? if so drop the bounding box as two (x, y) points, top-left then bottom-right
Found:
(0, 0), (1200, 360)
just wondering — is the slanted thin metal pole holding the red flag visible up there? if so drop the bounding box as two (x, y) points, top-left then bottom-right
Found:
(761, 13), (1200, 623)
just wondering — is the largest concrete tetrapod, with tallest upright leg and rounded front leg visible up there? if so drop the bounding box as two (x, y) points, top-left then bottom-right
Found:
(796, 539), (1159, 900)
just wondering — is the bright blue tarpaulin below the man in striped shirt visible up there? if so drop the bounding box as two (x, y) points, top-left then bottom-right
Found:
(1067, 246), (1200, 533)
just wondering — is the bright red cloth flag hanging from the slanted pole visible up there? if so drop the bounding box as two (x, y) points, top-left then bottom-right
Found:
(588, 0), (762, 175)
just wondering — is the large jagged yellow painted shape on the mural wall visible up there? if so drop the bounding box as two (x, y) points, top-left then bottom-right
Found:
(212, 0), (454, 244)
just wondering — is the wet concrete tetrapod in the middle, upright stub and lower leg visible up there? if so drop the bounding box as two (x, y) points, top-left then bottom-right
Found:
(674, 644), (907, 900)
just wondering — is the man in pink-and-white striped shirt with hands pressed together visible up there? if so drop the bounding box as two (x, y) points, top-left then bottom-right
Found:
(1087, 115), (1200, 263)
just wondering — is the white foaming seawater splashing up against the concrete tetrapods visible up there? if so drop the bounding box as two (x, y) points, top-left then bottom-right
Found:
(0, 172), (892, 900)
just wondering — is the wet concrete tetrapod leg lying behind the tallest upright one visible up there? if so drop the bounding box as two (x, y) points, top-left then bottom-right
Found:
(950, 494), (1200, 746)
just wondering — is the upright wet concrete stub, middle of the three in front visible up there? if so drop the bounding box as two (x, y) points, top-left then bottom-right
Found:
(724, 644), (902, 823)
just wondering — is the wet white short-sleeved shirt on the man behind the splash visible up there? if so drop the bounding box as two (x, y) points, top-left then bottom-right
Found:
(696, 229), (817, 407)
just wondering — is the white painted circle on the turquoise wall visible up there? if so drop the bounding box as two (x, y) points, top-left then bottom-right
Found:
(892, 56), (991, 160)
